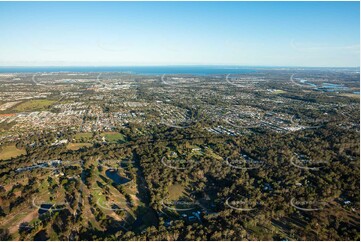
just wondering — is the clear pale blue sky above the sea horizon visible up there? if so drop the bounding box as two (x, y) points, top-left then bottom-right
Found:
(0, 2), (360, 67)
